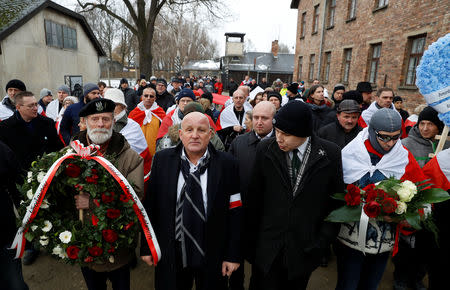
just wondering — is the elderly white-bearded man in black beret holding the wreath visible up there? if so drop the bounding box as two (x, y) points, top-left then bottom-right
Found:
(72, 99), (144, 290)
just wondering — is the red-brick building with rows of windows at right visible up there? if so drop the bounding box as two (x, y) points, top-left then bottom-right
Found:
(291, 0), (450, 109)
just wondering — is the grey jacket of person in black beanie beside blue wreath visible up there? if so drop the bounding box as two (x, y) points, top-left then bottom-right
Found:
(402, 126), (450, 167)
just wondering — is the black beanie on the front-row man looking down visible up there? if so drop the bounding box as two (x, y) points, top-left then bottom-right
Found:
(273, 101), (313, 137)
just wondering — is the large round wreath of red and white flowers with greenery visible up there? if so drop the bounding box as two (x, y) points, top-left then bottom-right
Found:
(18, 149), (139, 266)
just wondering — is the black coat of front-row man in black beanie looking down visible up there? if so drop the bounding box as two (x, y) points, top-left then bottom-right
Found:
(245, 135), (344, 280)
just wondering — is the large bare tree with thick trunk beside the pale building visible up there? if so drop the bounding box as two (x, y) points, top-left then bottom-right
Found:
(77, 0), (229, 75)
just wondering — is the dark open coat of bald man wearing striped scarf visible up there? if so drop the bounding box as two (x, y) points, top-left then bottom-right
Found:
(141, 144), (242, 289)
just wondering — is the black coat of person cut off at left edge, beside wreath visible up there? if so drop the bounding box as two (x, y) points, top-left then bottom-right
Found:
(0, 141), (23, 247)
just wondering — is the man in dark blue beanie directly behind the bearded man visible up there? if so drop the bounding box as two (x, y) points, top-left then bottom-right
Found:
(60, 83), (100, 145)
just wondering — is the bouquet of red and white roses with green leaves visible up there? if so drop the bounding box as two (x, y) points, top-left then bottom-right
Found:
(325, 178), (450, 235)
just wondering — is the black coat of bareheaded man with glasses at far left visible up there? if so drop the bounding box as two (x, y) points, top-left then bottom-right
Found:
(0, 111), (63, 170)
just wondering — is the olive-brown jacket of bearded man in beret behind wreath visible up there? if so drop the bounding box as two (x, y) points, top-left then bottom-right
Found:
(73, 131), (144, 272)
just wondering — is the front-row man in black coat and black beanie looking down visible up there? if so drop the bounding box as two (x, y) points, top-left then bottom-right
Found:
(246, 102), (344, 290)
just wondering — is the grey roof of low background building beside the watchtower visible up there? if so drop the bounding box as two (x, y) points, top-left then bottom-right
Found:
(229, 52), (294, 74)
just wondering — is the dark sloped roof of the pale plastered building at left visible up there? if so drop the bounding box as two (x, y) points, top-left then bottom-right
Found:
(0, 0), (106, 56)
